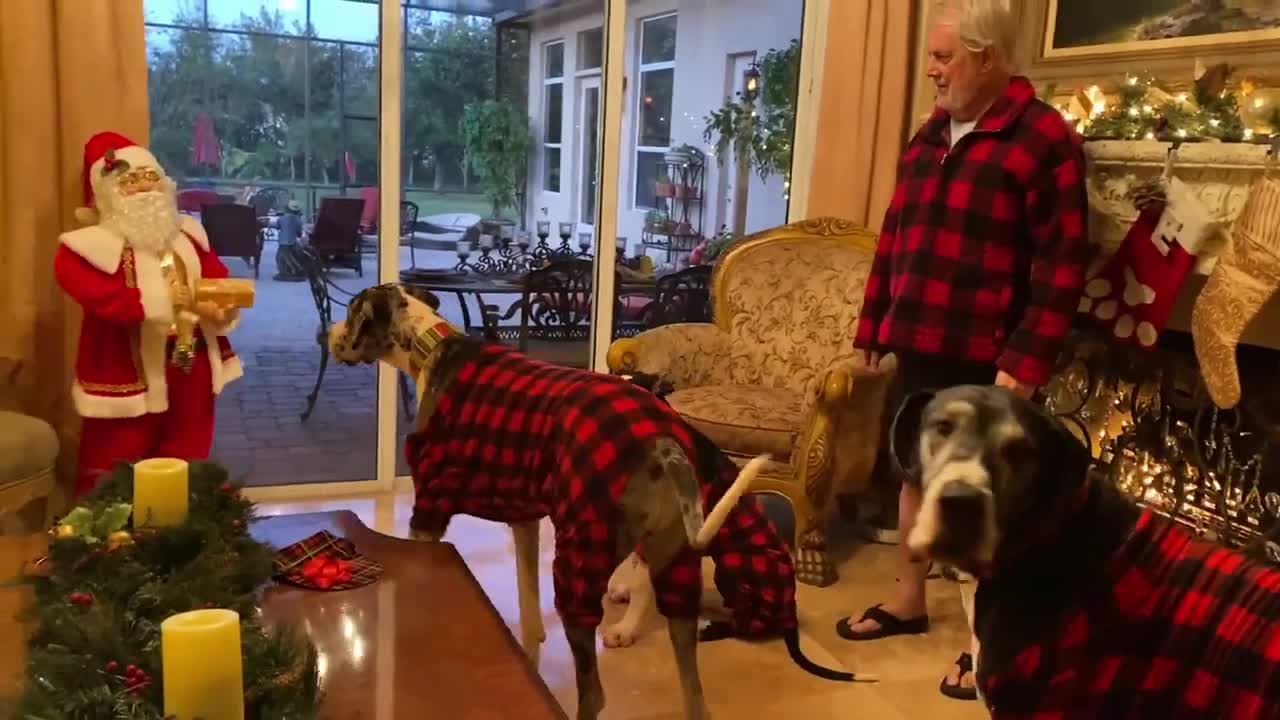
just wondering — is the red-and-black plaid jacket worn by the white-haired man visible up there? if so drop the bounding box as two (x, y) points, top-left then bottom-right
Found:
(854, 77), (1092, 386)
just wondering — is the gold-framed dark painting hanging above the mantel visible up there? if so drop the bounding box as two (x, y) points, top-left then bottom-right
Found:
(1042, 0), (1280, 58)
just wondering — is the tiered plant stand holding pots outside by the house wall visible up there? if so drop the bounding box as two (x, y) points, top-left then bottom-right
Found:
(640, 145), (707, 263)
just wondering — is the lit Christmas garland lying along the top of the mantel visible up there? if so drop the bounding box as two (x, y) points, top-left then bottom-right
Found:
(1041, 64), (1280, 143)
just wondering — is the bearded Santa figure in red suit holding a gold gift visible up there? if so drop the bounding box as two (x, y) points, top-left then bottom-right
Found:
(54, 132), (242, 497)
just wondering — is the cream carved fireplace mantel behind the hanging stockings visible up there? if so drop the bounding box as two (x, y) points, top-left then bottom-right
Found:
(1084, 140), (1280, 350)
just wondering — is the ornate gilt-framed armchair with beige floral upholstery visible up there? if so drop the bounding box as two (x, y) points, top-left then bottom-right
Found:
(608, 218), (896, 585)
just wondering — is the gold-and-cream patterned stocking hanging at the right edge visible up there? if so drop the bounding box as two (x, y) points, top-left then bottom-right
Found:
(1192, 178), (1280, 407)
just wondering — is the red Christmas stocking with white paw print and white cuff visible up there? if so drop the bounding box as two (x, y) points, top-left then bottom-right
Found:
(1080, 178), (1217, 348)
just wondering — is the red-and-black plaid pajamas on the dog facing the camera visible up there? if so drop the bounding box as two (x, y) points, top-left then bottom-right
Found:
(979, 510), (1280, 720)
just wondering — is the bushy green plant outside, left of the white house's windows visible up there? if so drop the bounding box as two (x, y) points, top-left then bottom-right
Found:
(458, 100), (532, 224)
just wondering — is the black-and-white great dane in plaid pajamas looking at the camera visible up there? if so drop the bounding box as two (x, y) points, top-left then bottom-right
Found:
(891, 386), (1280, 720)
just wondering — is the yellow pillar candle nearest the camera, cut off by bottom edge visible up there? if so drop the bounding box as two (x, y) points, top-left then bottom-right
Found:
(160, 610), (244, 720)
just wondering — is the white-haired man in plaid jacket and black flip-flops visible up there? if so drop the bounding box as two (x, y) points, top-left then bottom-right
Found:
(837, 0), (1092, 700)
